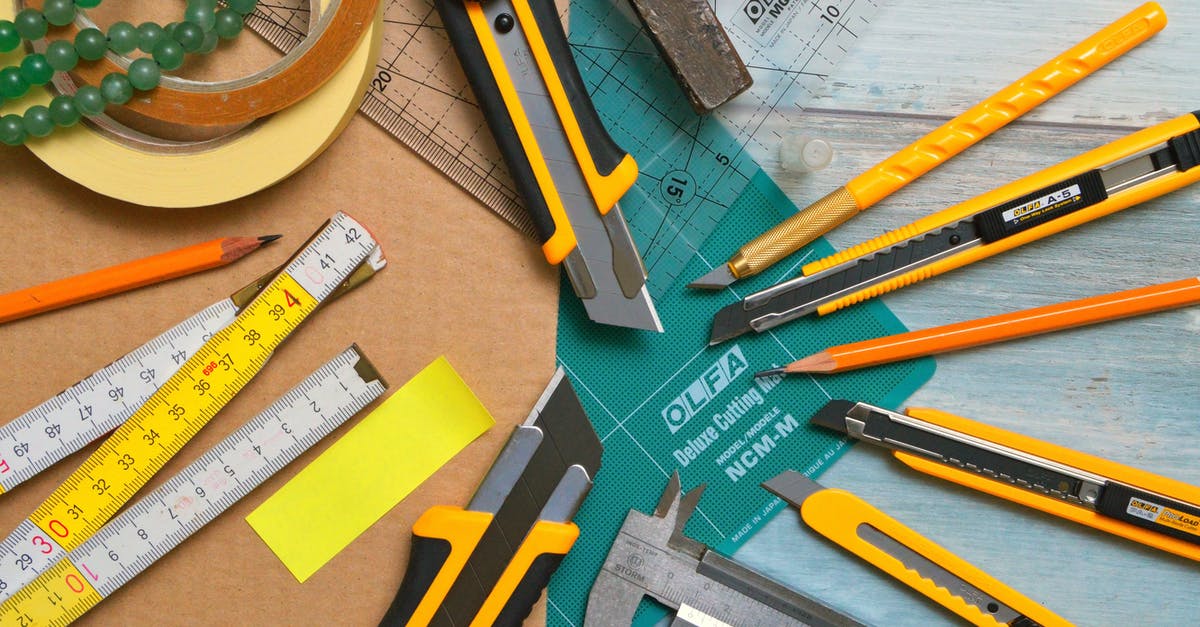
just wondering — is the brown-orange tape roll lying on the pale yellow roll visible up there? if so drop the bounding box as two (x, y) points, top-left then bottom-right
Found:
(25, 0), (379, 126)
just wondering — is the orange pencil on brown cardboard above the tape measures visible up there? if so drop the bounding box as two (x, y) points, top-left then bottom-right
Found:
(0, 235), (281, 324)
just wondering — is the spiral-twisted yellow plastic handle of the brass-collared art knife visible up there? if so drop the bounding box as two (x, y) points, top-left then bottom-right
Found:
(846, 2), (1166, 210)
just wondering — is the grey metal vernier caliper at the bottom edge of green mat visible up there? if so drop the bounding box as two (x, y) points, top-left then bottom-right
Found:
(583, 472), (862, 627)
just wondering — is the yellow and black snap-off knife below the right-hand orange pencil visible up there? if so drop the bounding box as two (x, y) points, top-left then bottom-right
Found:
(811, 400), (1200, 561)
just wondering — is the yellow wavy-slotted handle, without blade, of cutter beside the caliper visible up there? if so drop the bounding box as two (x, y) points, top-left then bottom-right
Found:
(800, 489), (1070, 627)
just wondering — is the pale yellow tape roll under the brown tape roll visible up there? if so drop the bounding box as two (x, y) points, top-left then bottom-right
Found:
(0, 1), (383, 208)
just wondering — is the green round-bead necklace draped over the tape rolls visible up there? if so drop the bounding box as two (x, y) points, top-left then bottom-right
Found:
(0, 0), (258, 145)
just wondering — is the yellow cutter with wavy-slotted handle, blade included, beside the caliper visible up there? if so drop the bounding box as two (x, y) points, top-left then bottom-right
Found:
(762, 471), (1070, 627)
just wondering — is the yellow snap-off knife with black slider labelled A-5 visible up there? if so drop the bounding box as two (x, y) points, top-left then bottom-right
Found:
(709, 107), (1200, 345)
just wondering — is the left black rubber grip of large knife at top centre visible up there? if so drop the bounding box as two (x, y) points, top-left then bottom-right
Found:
(433, 0), (556, 241)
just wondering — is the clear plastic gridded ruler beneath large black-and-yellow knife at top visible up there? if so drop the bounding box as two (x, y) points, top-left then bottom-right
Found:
(247, 0), (882, 288)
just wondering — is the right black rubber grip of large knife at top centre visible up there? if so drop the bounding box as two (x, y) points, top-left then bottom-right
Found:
(525, 0), (625, 175)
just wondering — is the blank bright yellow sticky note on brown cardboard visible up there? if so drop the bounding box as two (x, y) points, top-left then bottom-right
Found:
(246, 357), (496, 583)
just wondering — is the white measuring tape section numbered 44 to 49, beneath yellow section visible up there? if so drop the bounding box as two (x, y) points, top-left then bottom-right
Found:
(0, 247), (386, 494)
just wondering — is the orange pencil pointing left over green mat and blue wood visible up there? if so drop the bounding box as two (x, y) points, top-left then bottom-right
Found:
(755, 277), (1200, 377)
